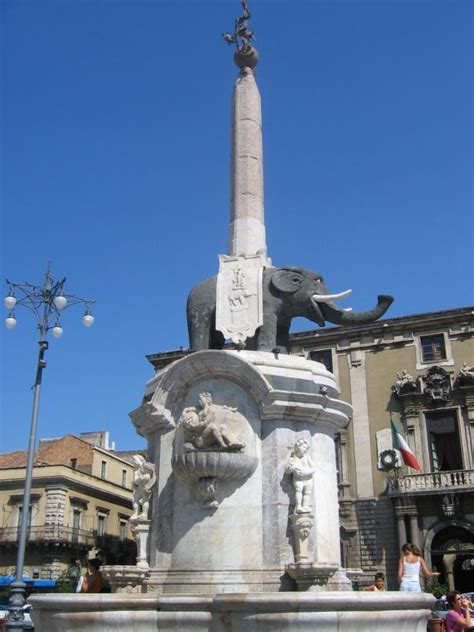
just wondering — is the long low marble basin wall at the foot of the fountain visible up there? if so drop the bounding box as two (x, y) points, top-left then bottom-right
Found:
(30, 592), (434, 632)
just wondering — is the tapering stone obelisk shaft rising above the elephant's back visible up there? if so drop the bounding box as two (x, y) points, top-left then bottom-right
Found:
(228, 68), (266, 256)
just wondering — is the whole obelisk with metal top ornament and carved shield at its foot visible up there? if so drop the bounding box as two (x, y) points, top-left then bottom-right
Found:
(216, 0), (271, 344)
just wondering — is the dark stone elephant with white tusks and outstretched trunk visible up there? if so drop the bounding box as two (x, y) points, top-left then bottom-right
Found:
(186, 267), (393, 353)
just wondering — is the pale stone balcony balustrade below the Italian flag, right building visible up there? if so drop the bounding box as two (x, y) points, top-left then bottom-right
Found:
(387, 470), (474, 496)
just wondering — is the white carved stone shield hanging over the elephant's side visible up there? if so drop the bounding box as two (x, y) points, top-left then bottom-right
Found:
(216, 254), (264, 344)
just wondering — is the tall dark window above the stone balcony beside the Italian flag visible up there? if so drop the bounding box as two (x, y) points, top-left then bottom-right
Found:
(425, 410), (463, 472)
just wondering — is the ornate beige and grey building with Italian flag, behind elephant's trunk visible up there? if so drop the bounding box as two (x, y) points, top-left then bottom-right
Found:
(148, 307), (474, 591)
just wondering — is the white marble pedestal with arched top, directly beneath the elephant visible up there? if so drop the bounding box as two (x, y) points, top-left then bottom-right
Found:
(131, 351), (351, 594)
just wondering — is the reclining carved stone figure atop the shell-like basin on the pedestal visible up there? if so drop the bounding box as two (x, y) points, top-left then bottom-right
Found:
(179, 392), (245, 451)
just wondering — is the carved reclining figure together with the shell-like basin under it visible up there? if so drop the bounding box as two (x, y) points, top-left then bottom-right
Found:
(171, 392), (257, 510)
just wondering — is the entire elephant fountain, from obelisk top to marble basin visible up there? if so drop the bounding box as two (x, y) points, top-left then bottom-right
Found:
(31, 0), (434, 632)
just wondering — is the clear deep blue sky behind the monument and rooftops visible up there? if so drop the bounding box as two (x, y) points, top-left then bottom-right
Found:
(0, 0), (474, 451)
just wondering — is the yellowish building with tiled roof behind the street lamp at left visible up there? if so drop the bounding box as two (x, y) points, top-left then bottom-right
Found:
(0, 432), (136, 579)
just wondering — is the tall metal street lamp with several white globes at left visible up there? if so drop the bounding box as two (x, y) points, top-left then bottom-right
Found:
(4, 265), (95, 630)
